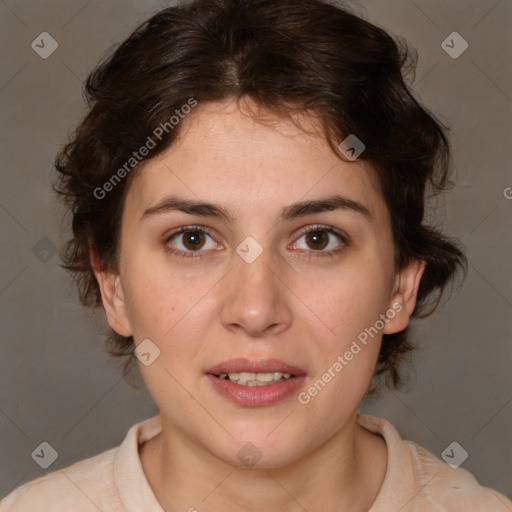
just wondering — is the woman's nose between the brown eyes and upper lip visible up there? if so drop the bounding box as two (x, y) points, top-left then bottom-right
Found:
(221, 242), (293, 337)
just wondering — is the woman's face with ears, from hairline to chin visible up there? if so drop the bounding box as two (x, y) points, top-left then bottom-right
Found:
(96, 98), (421, 467)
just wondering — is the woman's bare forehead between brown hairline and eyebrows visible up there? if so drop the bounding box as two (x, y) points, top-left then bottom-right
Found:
(126, 101), (386, 226)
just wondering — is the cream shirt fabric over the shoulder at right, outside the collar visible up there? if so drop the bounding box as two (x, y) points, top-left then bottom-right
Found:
(402, 441), (512, 512)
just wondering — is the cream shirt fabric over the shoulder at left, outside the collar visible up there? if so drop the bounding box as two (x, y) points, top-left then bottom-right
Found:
(0, 447), (118, 512)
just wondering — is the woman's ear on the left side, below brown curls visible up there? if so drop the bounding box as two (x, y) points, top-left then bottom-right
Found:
(89, 249), (132, 337)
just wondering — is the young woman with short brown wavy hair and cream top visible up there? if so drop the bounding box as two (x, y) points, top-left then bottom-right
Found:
(0, 0), (512, 512)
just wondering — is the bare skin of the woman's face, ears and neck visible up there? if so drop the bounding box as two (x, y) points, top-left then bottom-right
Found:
(91, 97), (424, 512)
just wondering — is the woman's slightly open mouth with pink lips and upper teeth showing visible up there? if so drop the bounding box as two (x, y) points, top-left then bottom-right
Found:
(205, 359), (306, 407)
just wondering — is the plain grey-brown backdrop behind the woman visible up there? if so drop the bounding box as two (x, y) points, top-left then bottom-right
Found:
(0, 0), (512, 502)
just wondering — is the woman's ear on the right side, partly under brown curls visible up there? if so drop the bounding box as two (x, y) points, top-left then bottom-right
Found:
(382, 260), (426, 334)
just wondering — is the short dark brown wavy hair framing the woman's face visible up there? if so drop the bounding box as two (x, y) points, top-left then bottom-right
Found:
(54, 0), (467, 396)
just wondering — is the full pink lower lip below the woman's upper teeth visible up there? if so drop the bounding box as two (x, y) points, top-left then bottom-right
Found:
(206, 374), (306, 407)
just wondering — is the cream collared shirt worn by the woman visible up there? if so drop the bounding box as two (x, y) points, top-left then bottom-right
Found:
(0, 414), (512, 512)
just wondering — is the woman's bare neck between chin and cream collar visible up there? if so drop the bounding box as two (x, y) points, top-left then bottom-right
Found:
(140, 414), (387, 512)
